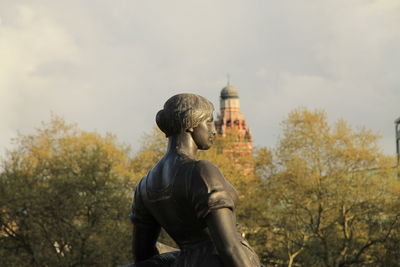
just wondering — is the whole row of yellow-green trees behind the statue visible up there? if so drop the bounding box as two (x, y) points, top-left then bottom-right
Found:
(0, 109), (400, 267)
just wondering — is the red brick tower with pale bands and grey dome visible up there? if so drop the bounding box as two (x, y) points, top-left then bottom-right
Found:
(215, 81), (253, 158)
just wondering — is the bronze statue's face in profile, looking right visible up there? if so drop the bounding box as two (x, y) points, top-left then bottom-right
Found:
(192, 115), (217, 150)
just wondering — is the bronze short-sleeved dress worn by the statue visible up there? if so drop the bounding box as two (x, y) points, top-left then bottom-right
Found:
(131, 153), (261, 267)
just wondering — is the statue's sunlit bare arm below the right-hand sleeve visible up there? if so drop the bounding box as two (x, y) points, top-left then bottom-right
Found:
(206, 208), (252, 267)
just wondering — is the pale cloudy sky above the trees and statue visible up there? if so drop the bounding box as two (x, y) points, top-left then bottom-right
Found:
(0, 0), (400, 155)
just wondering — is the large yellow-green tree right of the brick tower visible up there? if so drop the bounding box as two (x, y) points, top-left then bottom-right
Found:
(266, 109), (399, 267)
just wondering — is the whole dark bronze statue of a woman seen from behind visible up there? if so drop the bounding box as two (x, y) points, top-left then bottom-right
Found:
(131, 94), (260, 267)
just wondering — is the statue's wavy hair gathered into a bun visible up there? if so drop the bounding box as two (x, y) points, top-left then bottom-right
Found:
(156, 94), (214, 137)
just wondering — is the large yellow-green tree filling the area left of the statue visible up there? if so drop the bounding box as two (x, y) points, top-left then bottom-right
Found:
(0, 117), (135, 266)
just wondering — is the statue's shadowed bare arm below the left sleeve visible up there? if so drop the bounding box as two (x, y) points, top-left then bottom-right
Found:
(132, 224), (161, 262)
